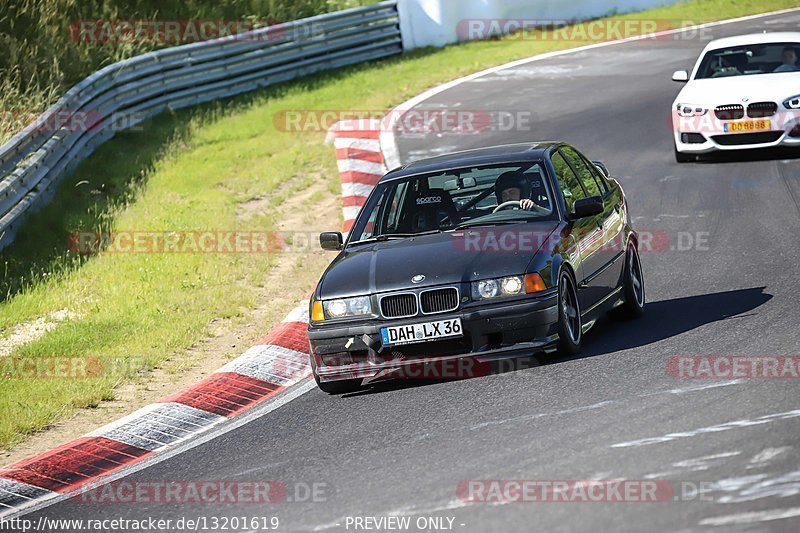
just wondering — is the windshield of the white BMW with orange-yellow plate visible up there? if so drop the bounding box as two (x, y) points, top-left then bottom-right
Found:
(695, 43), (800, 79)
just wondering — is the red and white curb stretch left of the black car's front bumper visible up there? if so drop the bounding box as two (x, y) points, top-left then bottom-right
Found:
(0, 302), (311, 516)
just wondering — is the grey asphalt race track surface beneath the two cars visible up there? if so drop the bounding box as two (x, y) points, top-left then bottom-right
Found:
(15, 8), (800, 531)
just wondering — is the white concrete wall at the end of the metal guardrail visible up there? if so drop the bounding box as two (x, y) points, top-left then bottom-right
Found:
(398, 0), (677, 50)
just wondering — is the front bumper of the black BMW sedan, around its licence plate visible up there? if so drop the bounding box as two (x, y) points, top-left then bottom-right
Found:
(308, 289), (558, 382)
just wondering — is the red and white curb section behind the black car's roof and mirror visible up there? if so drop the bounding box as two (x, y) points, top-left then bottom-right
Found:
(328, 119), (386, 232)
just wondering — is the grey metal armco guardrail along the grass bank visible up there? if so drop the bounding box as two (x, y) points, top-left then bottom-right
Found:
(0, 0), (402, 249)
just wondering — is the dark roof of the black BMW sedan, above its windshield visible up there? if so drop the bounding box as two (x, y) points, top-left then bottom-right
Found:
(381, 141), (564, 183)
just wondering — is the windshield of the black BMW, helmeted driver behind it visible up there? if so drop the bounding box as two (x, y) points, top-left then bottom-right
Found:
(350, 162), (556, 244)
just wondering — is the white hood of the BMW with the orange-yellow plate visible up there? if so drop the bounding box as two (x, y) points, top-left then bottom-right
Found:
(675, 72), (800, 108)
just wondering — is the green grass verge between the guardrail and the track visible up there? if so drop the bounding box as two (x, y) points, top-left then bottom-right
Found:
(0, 0), (797, 446)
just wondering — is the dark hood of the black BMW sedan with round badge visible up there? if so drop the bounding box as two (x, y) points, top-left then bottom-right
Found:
(319, 221), (558, 299)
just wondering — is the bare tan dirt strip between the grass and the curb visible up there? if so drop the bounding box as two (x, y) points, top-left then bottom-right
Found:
(0, 172), (341, 464)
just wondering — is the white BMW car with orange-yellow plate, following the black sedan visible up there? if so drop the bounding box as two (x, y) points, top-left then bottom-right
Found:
(672, 32), (800, 163)
